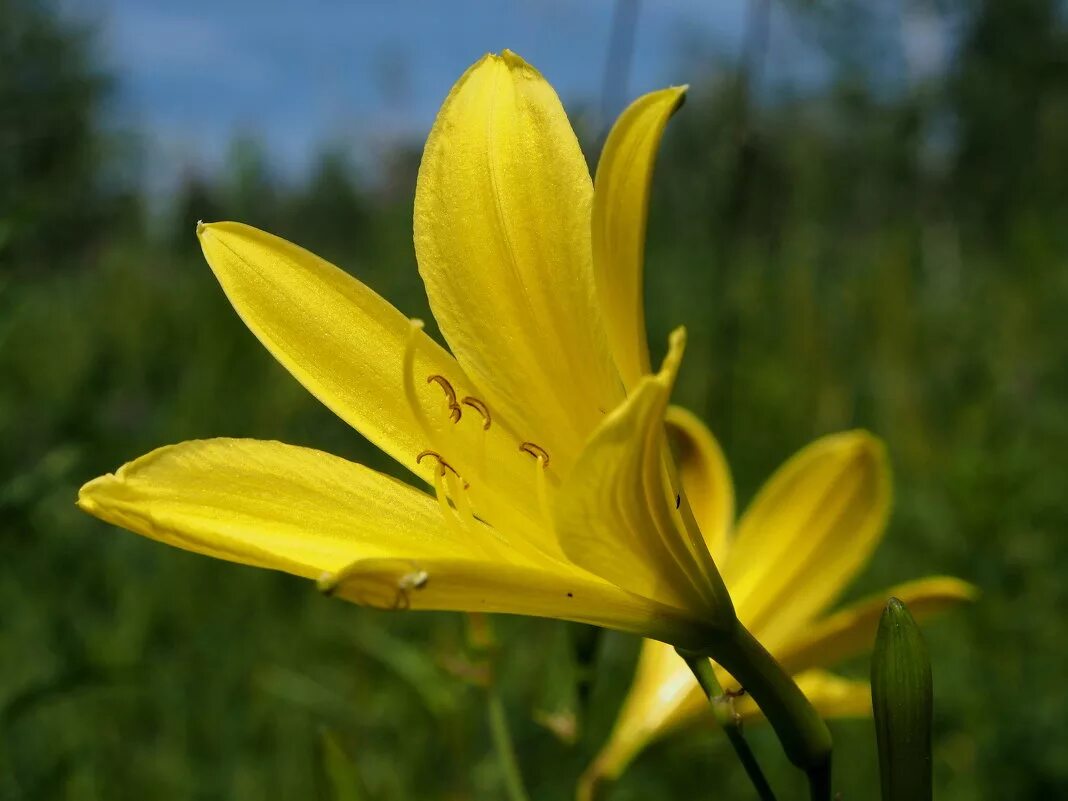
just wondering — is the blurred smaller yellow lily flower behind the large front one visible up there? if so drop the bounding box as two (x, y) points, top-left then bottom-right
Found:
(578, 407), (976, 799)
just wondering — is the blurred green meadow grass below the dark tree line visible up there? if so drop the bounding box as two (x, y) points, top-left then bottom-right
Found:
(0, 200), (1068, 801)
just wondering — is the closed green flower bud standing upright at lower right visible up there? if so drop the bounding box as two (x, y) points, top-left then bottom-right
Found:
(871, 598), (931, 801)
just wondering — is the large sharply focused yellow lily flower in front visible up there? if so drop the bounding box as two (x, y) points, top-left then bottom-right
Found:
(78, 51), (736, 647)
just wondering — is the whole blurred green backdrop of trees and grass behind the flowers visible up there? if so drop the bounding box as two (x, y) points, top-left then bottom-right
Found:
(0, 0), (1068, 801)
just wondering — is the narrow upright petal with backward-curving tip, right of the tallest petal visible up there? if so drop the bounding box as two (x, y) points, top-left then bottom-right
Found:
(593, 87), (686, 388)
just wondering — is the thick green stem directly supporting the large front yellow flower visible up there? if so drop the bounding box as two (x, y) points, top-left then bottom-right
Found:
(708, 623), (831, 801)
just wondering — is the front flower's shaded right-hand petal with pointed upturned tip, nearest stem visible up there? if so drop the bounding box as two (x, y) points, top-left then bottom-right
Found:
(554, 329), (734, 626)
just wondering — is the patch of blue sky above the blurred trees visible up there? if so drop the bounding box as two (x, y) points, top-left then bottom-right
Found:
(75, 0), (939, 187)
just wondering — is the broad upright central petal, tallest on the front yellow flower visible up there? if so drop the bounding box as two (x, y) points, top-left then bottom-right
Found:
(414, 51), (623, 472)
